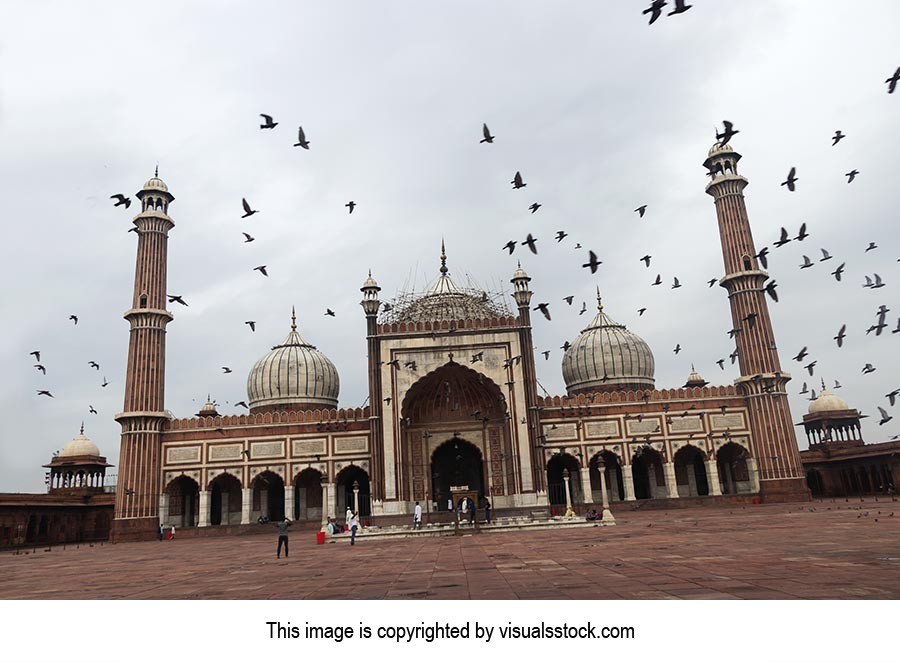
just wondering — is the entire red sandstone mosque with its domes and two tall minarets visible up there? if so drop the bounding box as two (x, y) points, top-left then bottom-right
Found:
(113, 144), (809, 539)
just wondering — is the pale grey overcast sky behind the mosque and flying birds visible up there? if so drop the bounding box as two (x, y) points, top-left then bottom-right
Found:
(0, 0), (900, 491)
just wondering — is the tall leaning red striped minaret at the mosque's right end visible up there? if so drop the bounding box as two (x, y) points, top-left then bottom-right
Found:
(703, 143), (809, 501)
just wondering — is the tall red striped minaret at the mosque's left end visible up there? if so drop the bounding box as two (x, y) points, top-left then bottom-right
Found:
(112, 170), (175, 540)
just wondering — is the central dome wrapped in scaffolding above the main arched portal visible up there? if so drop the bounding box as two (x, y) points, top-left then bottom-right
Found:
(382, 242), (510, 322)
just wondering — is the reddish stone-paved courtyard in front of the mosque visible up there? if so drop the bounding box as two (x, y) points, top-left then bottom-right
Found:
(0, 499), (900, 599)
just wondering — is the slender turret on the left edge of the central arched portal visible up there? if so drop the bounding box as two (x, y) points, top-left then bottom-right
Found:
(359, 270), (384, 501)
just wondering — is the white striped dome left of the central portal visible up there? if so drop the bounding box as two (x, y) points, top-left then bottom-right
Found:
(247, 318), (341, 411)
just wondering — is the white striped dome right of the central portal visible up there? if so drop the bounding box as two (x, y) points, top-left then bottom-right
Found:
(562, 297), (654, 395)
